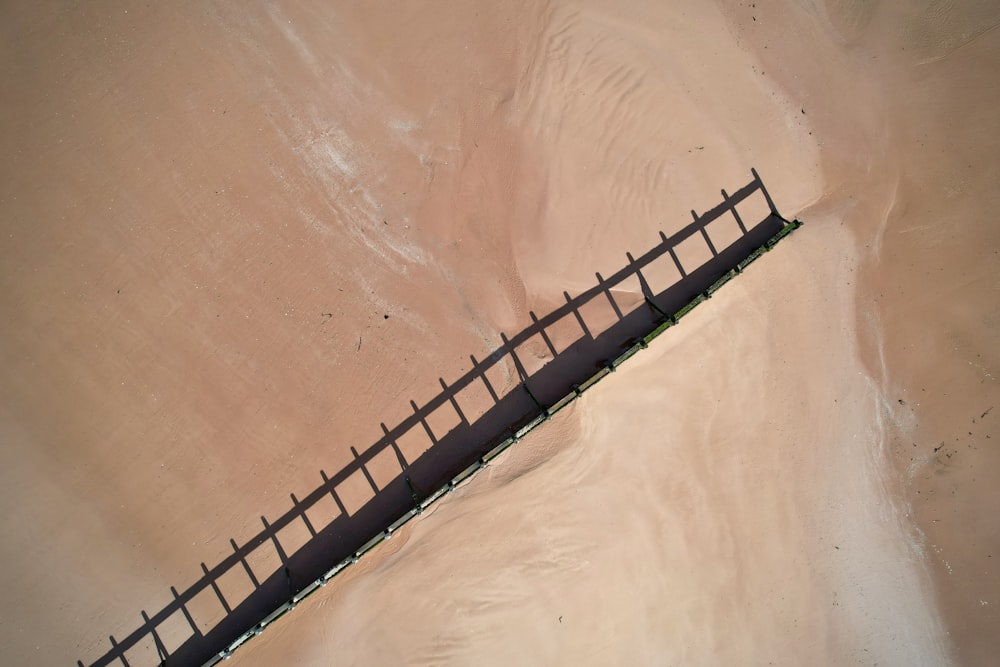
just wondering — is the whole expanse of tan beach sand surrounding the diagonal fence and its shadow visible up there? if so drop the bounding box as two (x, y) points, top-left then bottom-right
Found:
(0, 0), (1000, 665)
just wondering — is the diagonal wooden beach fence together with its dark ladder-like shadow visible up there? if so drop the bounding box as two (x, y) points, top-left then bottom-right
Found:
(78, 170), (802, 667)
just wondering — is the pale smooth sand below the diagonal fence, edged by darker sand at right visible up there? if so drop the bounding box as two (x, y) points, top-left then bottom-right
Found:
(234, 218), (945, 665)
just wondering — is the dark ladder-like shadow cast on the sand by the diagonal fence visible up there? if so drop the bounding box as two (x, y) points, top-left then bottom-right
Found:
(78, 170), (788, 667)
